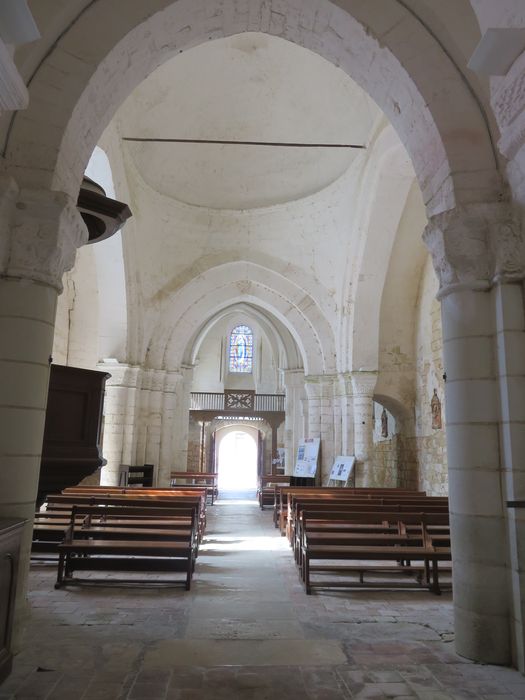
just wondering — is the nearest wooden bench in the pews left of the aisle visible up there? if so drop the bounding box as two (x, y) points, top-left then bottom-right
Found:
(55, 506), (197, 590)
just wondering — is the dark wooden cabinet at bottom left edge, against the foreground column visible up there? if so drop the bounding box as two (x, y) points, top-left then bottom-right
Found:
(0, 518), (26, 683)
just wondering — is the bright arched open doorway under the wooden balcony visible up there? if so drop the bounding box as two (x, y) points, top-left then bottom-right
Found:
(218, 430), (257, 493)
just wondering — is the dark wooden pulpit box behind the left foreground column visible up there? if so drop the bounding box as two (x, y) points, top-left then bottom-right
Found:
(38, 365), (111, 504)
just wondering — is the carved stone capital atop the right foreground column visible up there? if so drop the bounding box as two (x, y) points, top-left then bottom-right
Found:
(423, 202), (525, 298)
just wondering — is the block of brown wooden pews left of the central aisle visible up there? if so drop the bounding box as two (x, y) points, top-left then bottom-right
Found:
(32, 486), (207, 590)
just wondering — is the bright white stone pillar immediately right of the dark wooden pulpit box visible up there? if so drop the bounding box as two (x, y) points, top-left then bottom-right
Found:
(97, 360), (140, 486)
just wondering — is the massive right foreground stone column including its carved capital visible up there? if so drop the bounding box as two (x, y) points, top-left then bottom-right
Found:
(424, 204), (525, 668)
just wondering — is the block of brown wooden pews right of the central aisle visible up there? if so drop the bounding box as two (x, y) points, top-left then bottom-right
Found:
(275, 487), (451, 595)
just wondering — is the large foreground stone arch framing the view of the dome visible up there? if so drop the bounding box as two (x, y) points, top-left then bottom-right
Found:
(4, 0), (501, 214)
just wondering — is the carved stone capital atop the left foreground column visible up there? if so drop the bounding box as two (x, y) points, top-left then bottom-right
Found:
(0, 176), (88, 292)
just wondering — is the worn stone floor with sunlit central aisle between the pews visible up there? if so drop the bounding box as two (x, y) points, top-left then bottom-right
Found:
(0, 501), (525, 700)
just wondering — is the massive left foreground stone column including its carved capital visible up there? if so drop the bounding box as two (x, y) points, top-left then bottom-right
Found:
(0, 178), (87, 638)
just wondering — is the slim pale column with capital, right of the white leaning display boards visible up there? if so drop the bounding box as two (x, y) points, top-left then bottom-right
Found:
(352, 371), (377, 488)
